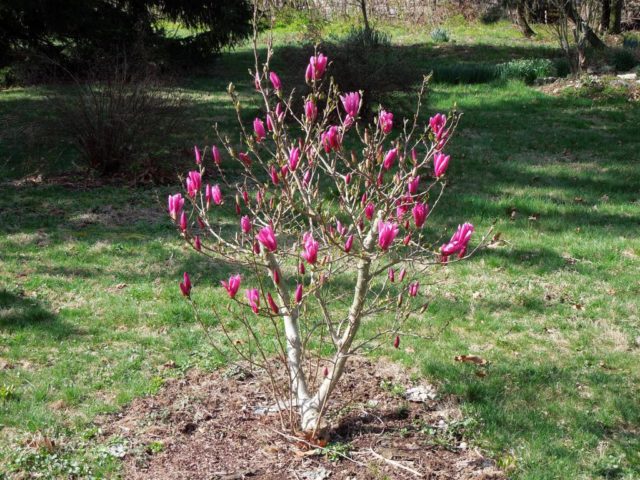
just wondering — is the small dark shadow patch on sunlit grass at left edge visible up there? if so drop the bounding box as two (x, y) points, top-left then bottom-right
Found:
(0, 290), (77, 339)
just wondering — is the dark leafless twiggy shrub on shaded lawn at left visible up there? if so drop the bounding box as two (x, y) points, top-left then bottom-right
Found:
(50, 61), (184, 175)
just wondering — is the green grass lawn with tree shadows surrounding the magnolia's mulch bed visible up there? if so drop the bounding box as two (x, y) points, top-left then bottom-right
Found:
(0, 20), (640, 480)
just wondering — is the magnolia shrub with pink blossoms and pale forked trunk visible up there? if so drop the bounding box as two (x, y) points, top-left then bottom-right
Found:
(169, 48), (474, 432)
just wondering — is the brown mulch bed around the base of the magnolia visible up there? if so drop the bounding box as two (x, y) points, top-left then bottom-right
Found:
(99, 358), (505, 480)
